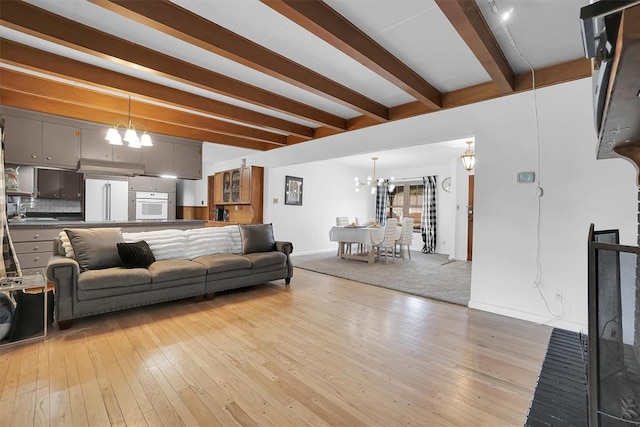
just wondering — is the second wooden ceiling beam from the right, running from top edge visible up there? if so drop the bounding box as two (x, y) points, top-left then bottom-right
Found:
(261, 0), (442, 110)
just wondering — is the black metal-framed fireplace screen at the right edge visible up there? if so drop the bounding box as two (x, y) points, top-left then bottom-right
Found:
(588, 226), (640, 426)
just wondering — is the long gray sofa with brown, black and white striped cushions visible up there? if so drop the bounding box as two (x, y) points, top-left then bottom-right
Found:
(46, 224), (293, 329)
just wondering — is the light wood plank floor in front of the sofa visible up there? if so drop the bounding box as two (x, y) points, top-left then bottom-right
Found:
(0, 269), (550, 426)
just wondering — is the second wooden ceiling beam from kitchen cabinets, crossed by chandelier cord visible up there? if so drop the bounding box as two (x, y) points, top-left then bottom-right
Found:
(0, 69), (287, 146)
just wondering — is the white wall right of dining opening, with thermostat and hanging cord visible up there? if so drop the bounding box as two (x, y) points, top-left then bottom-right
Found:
(470, 80), (637, 331)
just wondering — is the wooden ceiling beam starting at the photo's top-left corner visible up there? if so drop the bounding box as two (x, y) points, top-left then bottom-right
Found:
(0, 1), (346, 130)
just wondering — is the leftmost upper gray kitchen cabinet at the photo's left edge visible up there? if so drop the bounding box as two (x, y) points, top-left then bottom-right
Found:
(3, 114), (42, 165)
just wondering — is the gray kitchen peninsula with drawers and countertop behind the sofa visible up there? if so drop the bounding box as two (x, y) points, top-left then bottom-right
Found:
(9, 217), (206, 275)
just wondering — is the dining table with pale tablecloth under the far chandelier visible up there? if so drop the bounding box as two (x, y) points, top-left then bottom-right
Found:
(329, 225), (402, 264)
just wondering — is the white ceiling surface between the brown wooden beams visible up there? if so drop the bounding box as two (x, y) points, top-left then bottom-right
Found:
(0, 0), (589, 166)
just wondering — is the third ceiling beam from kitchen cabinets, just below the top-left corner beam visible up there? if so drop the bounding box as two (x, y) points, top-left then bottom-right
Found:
(0, 38), (314, 139)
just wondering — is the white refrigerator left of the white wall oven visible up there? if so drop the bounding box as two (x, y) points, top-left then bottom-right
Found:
(84, 178), (129, 221)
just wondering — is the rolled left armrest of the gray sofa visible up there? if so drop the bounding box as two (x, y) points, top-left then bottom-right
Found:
(47, 255), (80, 320)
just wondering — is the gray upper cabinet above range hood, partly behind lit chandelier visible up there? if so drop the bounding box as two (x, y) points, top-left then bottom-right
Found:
(80, 128), (143, 164)
